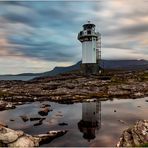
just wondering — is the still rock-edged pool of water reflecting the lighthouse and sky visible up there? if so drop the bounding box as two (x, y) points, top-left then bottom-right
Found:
(0, 98), (148, 147)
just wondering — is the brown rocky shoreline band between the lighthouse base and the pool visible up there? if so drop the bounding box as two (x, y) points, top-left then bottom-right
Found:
(0, 71), (148, 103)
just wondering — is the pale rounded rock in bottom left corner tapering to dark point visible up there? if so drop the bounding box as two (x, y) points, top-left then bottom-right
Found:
(0, 126), (67, 147)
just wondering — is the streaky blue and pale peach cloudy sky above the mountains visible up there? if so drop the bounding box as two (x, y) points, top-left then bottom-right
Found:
(0, 0), (148, 74)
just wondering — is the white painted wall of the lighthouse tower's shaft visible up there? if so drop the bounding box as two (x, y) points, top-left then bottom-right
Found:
(82, 41), (96, 63)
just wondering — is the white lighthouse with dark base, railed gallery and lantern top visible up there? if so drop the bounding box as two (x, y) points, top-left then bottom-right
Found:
(78, 21), (101, 74)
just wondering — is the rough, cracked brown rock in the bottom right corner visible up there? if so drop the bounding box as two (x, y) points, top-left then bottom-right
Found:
(117, 120), (148, 147)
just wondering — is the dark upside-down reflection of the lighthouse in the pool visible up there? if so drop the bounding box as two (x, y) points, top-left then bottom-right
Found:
(78, 102), (101, 141)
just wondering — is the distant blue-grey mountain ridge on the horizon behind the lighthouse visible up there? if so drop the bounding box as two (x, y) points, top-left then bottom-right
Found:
(1, 60), (148, 77)
